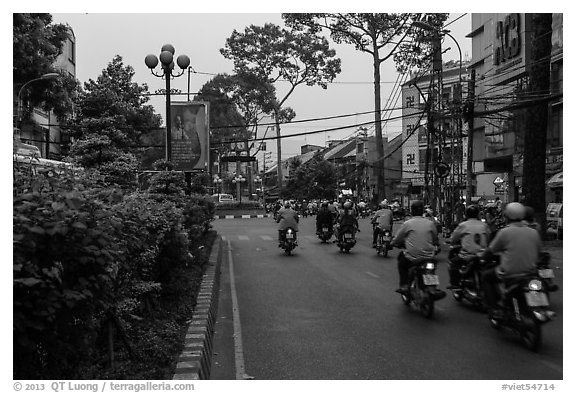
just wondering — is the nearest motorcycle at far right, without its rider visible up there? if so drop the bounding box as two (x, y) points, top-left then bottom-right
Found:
(488, 274), (555, 351)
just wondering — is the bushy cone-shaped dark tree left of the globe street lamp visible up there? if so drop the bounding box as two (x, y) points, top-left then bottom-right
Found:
(69, 56), (160, 185)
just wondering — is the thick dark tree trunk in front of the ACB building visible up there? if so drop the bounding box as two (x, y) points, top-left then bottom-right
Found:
(522, 14), (552, 228)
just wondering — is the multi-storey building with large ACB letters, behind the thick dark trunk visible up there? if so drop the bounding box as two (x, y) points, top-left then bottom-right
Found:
(468, 13), (563, 202)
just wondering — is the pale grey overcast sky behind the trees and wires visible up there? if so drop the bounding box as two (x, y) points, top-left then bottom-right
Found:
(44, 8), (471, 159)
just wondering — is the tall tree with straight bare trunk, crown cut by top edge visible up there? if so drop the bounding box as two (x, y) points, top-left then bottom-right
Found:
(282, 13), (448, 199)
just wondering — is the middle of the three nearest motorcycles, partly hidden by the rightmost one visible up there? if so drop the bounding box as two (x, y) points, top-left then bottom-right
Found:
(448, 246), (484, 310)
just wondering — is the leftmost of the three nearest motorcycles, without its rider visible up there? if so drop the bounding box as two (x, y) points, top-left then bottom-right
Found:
(400, 259), (446, 318)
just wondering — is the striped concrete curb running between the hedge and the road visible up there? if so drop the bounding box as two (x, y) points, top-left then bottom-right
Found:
(172, 236), (223, 380)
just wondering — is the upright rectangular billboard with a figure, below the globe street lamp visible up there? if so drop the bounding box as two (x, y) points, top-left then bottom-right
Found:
(170, 101), (210, 171)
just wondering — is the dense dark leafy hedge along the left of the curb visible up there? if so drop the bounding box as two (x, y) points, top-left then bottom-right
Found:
(13, 161), (214, 379)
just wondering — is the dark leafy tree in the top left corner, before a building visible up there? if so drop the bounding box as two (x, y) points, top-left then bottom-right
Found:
(12, 13), (79, 120)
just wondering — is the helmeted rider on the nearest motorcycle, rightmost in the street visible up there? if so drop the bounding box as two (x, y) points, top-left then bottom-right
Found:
(481, 202), (542, 316)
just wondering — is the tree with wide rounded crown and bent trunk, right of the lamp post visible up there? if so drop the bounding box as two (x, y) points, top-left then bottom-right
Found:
(220, 23), (341, 189)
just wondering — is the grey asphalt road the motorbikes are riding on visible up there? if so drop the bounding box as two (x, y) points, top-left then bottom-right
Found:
(211, 217), (563, 380)
